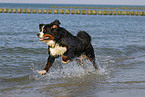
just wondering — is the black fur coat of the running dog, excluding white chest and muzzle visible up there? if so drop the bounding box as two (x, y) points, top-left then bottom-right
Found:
(39, 20), (98, 74)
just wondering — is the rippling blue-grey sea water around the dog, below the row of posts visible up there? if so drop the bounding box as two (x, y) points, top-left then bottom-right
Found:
(0, 5), (145, 97)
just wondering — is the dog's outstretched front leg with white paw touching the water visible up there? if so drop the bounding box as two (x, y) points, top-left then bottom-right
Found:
(39, 55), (55, 75)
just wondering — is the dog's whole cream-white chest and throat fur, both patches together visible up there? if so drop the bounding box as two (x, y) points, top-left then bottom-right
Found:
(47, 41), (67, 56)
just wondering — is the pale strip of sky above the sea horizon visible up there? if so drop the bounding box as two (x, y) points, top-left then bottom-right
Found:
(0, 0), (145, 6)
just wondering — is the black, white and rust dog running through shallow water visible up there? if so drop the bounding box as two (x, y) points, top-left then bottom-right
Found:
(37, 20), (98, 74)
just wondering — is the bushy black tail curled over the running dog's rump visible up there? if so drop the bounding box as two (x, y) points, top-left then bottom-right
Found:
(77, 31), (91, 43)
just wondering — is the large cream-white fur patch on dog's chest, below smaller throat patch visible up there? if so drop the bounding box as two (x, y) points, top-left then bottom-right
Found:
(49, 44), (67, 56)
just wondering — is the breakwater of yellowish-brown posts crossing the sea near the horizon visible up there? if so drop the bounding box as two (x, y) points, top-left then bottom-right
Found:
(0, 5), (145, 16)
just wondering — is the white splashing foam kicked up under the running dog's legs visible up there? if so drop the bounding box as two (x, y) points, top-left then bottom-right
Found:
(31, 60), (112, 80)
